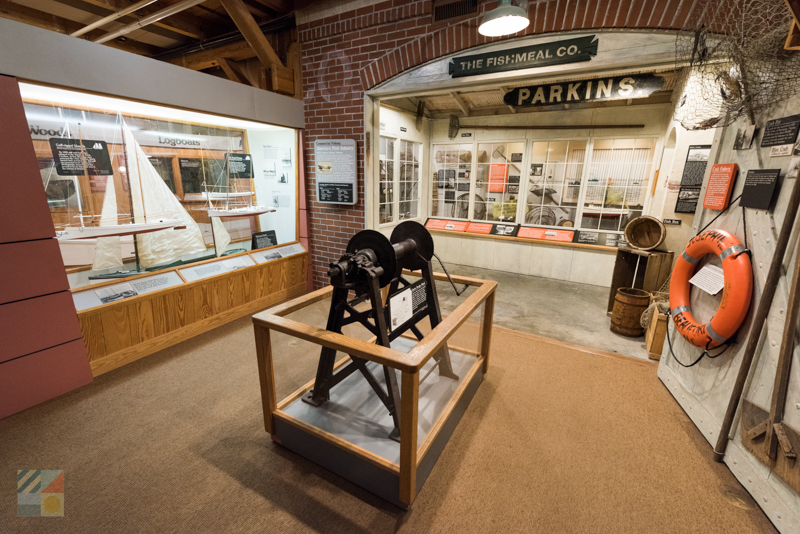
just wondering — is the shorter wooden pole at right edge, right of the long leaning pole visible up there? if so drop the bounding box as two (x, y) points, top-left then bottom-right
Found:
(764, 242), (800, 460)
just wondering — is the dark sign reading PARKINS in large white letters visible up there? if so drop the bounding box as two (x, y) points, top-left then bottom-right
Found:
(503, 74), (664, 108)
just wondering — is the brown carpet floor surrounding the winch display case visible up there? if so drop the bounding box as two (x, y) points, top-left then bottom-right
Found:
(0, 305), (775, 534)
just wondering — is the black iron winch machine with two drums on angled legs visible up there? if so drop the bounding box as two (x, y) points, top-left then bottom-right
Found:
(303, 221), (466, 441)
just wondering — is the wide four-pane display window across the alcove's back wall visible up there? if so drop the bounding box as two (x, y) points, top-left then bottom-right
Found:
(430, 138), (656, 233)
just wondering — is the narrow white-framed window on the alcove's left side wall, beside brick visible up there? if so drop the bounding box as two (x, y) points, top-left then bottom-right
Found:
(378, 136), (422, 224)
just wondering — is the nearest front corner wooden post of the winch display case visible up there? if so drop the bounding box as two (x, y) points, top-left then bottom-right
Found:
(398, 369), (419, 506)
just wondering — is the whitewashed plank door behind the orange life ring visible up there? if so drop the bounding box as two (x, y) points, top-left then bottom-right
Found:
(658, 94), (800, 533)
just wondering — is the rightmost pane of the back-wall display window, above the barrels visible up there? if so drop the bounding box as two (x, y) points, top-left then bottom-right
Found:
(580, 138), (656, 232)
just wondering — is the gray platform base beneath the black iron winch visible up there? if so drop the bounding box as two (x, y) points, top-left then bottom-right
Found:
(275, 338), (483, 508)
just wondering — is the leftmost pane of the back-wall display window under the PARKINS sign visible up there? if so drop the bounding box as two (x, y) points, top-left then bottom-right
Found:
(431, 143), (473, 219)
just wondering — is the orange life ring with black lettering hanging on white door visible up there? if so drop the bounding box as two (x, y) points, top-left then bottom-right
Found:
(669, 230), (753, 349)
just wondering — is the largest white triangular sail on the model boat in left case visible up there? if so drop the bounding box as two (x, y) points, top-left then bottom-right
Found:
(122, 121), (206, 268)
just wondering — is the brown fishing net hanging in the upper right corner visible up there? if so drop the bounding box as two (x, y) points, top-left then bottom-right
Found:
(674, 0), (800, 130)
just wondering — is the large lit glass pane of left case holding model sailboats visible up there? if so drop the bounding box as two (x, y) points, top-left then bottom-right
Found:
(20, 83), (297, 287)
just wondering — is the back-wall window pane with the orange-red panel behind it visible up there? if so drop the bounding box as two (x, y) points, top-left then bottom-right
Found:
(473, 141), (525, 222)
